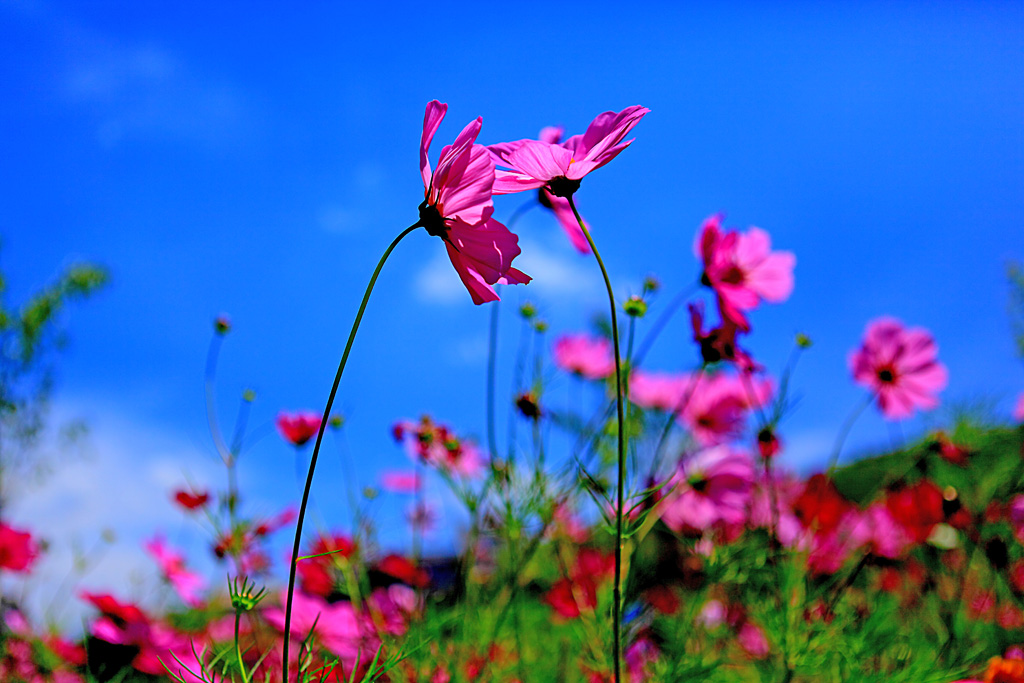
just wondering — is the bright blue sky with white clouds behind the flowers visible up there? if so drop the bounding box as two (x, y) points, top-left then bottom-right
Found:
(0, 0), (1024, 626)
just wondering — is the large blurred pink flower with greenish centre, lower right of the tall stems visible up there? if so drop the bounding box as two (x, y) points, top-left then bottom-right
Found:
(662, 445), (754, 531)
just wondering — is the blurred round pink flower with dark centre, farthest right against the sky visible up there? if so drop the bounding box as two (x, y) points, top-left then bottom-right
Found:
(850, 317), (947, 420)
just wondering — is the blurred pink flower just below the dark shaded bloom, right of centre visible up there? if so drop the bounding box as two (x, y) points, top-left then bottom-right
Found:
(680, 373), (772, 446)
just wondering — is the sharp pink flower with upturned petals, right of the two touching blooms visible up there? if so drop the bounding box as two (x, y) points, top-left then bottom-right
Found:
(488, 105), (650, 198)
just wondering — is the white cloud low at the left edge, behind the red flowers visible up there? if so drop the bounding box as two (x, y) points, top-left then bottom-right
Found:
(4, 404), (222, 629)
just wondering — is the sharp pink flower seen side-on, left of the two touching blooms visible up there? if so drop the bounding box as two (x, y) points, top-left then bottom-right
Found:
(418, 99), (530, 304)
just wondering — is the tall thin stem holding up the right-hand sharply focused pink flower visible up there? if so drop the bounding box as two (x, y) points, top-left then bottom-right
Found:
(567, 195), (626, 683)
